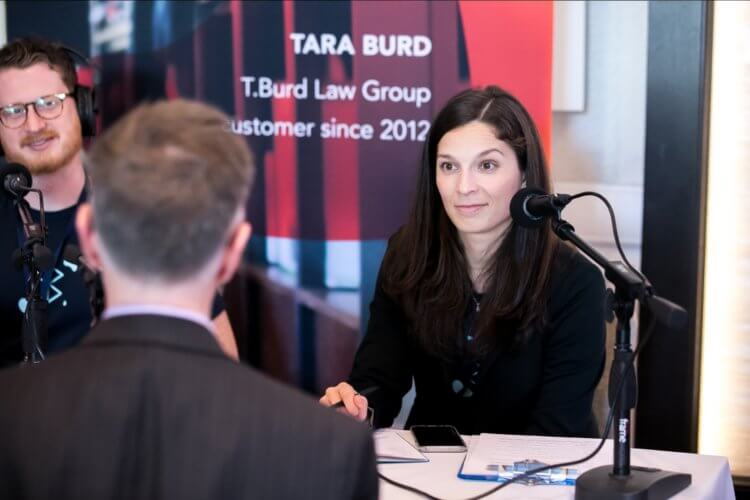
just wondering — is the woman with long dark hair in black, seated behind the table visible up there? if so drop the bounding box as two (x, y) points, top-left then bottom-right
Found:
(321, 86), (605, 436)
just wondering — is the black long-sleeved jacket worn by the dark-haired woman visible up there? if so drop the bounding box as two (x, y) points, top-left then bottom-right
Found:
(349, 245), (605, 436)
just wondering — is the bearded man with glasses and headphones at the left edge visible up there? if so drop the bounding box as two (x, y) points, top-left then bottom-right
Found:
(0, 38), (237, 368)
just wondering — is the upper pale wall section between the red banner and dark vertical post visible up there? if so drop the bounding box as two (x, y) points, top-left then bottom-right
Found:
(552, 2), (648, 186)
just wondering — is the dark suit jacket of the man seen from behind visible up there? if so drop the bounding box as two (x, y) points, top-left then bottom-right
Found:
(0, 315), (378, 500)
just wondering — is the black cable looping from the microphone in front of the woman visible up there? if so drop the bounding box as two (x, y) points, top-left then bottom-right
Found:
(378, 191), (656, 500)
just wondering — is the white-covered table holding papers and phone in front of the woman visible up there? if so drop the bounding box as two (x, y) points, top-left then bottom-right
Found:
(378, 431), (734, 500)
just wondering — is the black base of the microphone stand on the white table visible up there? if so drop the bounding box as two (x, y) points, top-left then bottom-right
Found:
(575, 465), (691, 500)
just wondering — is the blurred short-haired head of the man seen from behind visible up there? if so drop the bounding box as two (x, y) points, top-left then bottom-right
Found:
(79, 99), (254, 283)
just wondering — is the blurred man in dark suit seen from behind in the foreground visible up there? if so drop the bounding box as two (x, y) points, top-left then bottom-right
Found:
(0, 100), (377, 500)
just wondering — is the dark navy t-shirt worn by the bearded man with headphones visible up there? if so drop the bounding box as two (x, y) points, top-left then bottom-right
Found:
(0, 196), (224, 368)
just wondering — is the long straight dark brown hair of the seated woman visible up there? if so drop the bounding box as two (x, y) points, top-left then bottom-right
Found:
(381, 86), (556, 358)
